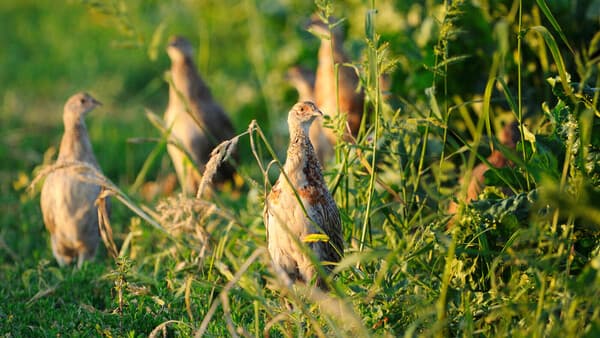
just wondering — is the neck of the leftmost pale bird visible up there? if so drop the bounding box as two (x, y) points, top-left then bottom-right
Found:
(58, 119), (98, 166)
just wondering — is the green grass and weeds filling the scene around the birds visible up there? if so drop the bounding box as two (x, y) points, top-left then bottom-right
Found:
(0, 0), (600, 337)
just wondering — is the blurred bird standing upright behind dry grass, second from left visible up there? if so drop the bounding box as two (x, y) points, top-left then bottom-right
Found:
(164, 36), (235, 194)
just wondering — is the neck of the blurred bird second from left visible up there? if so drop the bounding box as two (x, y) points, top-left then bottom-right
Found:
(169, 57), (212, 100)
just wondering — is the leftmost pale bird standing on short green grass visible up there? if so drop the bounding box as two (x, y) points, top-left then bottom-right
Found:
(40, 92), (108, 268)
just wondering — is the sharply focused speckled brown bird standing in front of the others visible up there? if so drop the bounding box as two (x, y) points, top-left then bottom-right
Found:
(264, 101), (344, 290)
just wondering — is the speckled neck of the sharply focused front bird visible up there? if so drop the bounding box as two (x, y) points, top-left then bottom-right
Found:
(283, 127), (325, 185)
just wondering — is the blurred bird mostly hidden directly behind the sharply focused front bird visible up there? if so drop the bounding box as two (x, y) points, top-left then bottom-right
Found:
(287, 66), (333, 166)
